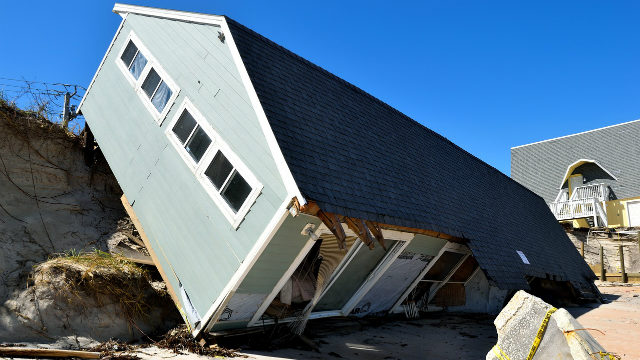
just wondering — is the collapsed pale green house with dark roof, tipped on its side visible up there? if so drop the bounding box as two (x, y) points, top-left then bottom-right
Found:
(79, 4), (597, 336)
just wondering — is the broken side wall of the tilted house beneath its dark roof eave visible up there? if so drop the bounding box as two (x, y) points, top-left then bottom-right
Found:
(207, 201), (597, 332)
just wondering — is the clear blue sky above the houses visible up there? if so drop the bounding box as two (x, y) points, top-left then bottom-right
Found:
(0, 0), (640, 174)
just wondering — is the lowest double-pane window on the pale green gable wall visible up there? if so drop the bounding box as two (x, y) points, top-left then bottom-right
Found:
(204, 151), (252, 212)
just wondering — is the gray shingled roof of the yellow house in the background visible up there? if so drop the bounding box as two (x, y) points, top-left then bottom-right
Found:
(511, 120), (640, 202)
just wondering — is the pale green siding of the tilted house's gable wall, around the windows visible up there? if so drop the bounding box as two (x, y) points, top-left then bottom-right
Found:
(81, 14), (287, 316)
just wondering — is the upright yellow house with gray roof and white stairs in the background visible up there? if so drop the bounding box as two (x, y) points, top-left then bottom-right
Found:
(511, 120), (640, 228)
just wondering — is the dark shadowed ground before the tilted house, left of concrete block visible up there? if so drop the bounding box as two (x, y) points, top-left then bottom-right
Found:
(244, 314), (497, 360)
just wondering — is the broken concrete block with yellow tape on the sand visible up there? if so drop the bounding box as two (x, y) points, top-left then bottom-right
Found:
(486, 290), (606, 360)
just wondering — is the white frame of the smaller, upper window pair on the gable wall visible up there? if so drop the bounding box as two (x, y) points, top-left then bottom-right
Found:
(116, 31), (180, 125)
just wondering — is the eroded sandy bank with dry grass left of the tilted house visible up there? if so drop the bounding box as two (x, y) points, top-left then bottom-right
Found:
(0, 99), (176, 346)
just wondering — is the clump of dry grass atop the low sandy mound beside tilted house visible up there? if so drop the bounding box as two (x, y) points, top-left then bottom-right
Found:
(33, 250), (153, 322)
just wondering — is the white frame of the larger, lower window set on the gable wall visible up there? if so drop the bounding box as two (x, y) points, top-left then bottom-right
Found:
(165, 98), (264, 229)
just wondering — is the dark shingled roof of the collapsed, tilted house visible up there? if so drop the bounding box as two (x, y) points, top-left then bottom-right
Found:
(228, 19), (595, 289)
